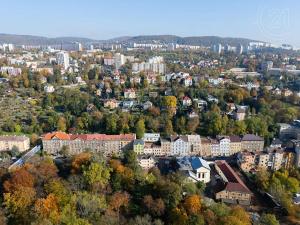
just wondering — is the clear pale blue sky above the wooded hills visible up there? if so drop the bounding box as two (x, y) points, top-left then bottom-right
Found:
(0, 0), (300, 48)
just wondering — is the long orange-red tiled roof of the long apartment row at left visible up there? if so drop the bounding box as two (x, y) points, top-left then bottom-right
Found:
(43, 131), (135, 141)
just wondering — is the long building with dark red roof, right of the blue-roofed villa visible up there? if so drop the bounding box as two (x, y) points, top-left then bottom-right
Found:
(215, 160), (252, 205)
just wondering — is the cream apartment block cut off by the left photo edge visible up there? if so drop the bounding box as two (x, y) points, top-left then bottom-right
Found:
(0, 135), (30, 152)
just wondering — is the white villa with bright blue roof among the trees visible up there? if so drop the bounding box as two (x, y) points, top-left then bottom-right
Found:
(177, 157), (210, 183)
